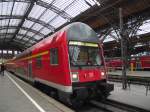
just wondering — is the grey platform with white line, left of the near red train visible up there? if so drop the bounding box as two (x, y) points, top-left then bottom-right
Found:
(0, 72), (73, 112)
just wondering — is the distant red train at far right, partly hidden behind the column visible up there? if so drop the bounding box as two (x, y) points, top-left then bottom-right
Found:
(106, 56), (150, 70)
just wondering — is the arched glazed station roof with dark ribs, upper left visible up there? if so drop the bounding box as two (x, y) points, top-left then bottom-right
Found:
(0, 0), (96, 50)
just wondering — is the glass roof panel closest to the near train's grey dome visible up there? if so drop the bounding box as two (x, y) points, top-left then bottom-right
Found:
(50, 16), (67, 28)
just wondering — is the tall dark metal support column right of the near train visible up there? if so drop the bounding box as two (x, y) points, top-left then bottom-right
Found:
(119, 8), (127, 89)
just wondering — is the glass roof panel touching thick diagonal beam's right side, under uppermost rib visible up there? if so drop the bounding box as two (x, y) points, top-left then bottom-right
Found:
(29, 5), (46, 19)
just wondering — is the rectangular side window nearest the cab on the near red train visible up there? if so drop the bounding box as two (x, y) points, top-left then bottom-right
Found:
(50, 48), (58, 65)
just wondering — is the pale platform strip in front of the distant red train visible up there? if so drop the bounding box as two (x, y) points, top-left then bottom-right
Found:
(108, 70), (150, 77)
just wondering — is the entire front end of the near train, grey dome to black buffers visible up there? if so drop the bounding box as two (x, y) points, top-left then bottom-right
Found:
(63, 22), (114, 103)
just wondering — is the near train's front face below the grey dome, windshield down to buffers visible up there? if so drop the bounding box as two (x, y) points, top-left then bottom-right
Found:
(69, 41), (113, 100)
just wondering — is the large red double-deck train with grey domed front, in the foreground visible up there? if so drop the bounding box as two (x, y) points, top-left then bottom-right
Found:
(7, 22), (114, 104)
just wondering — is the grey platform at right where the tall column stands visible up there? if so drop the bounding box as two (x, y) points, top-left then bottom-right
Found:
(108, 82), (150, 110)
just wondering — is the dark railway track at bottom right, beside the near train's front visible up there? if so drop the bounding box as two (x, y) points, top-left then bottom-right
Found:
(77, 100), (150, 112)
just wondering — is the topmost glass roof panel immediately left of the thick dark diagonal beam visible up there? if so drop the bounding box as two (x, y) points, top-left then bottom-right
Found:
(12, 2), (28, 15)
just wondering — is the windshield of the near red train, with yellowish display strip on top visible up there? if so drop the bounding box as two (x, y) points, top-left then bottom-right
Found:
(69, 43), (102, 66)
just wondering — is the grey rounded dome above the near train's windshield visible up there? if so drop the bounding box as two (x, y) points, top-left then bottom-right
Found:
(62, 22), (99, 43)
